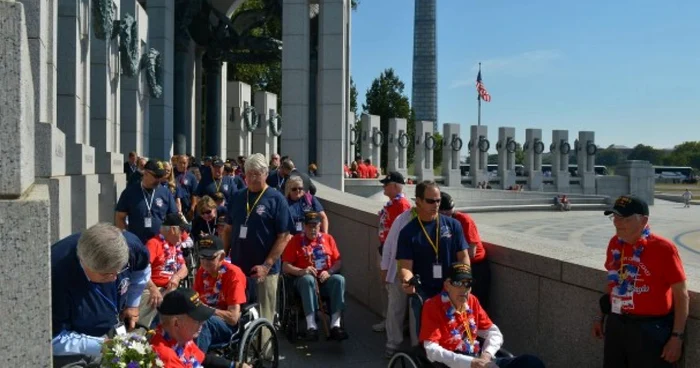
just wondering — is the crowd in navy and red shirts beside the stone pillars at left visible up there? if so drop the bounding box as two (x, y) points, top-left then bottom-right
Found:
(51, 154), (348, 368)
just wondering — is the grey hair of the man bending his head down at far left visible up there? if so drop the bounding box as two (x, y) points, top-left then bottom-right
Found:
(77, 223), (129, 273)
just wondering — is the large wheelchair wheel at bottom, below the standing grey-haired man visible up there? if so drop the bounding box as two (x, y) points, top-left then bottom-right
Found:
(238, 318), (279, 368)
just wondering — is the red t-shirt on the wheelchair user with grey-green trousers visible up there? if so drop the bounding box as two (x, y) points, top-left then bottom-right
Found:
(282, 233), (340, 272)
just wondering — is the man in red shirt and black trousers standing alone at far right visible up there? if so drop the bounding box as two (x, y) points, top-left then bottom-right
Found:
(593, 195), (689, 368)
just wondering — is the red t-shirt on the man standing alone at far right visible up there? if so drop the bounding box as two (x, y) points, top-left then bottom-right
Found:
(605, 233), (686, 316)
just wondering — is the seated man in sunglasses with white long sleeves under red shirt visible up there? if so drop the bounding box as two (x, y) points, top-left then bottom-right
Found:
(419, 263), (544, 368)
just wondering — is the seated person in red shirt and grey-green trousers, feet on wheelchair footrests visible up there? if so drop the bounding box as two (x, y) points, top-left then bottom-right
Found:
(282, 212), (348, 341)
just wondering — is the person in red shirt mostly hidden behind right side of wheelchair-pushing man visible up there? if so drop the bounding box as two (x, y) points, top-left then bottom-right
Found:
(440, 192), (491, 309)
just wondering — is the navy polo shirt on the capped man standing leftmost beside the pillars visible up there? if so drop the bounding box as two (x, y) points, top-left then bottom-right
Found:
(116, 185), (177, 243)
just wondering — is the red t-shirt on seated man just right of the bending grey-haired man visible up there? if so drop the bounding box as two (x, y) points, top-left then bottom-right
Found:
(146, 235), (185, 287)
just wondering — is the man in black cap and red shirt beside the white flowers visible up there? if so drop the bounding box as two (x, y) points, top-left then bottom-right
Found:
(151, 289), (250, 368)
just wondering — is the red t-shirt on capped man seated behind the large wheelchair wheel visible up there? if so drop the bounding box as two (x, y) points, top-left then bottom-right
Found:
(194, 261), (247, 310)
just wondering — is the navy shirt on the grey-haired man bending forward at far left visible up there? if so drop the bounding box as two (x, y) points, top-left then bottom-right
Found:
(51, 231), (149, 336)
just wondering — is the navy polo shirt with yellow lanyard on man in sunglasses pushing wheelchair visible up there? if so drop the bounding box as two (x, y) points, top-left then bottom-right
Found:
(396, 215), (469, 297)
